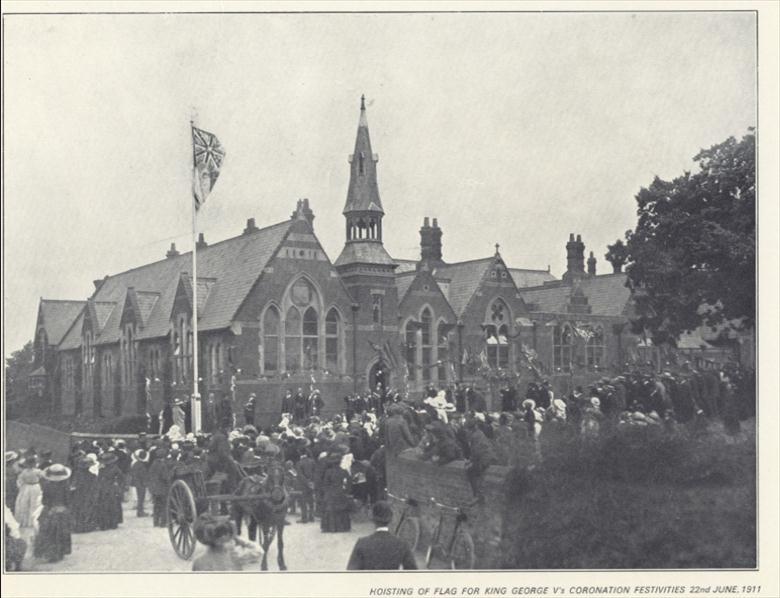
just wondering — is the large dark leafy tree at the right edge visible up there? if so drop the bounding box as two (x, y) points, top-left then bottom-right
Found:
(626, 128), (756, 343)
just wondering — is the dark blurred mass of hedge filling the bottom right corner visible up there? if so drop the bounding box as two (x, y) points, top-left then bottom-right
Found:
(501, 428), (756, 569)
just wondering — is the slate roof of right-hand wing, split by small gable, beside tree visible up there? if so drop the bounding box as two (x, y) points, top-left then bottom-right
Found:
(520, 272), (631, 316)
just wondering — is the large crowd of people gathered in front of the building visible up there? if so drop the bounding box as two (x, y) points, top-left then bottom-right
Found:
(6, 366), (755, 569)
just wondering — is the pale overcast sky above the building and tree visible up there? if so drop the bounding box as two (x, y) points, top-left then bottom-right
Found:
(3, 13), (756, 355)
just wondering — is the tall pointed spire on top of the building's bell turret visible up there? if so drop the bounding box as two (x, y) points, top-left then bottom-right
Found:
(344, 96), (384, 216)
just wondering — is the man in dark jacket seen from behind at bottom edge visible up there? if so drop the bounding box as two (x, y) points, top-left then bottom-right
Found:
(347, 500), (417, 571)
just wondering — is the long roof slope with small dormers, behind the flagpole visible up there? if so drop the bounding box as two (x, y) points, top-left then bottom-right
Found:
(83, 220), (298, 348)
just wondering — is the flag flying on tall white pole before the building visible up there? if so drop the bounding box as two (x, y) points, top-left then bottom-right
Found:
(190, 120), (225, 433)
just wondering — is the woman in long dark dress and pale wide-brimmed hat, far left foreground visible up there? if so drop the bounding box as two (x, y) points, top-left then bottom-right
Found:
(34, 463), (71, 563)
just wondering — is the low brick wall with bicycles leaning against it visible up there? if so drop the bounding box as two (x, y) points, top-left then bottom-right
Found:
(387, 449), (510, 569)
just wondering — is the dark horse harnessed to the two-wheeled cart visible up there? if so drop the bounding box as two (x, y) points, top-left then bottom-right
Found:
(233, 460), (289, 571)
